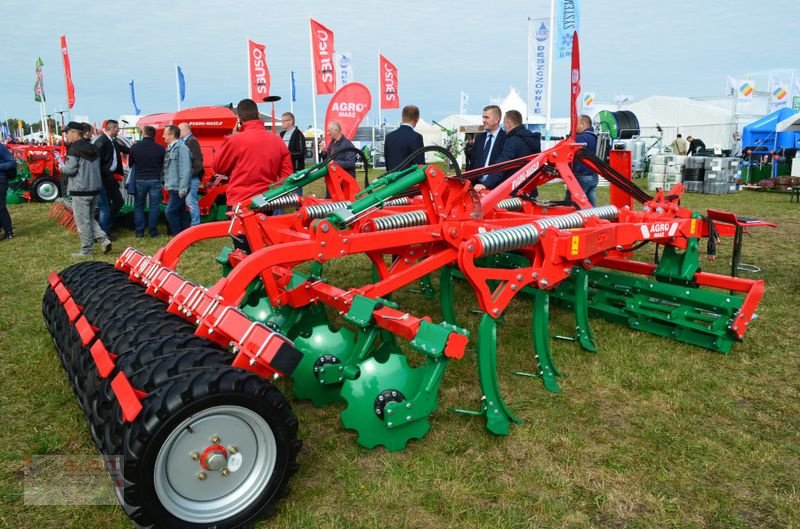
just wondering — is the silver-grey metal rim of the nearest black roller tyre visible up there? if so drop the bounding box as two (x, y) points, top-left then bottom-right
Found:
(154, 406), (278, 523)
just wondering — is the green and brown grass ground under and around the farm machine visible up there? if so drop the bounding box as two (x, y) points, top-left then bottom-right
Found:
(0, 186), (800, 529)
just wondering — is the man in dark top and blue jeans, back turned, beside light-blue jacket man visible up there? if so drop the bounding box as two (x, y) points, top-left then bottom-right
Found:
(128, 125), (166, 239)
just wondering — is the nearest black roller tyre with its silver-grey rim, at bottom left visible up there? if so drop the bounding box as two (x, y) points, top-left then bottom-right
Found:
(119, 366), (301, 529)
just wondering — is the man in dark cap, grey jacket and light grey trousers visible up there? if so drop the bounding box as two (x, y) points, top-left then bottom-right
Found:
(59, 121), (111, 257)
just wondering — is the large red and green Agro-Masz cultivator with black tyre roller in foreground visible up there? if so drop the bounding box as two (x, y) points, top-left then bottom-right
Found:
(43, 36), (776, 528)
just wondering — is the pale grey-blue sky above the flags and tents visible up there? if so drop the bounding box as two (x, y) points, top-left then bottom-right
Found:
(0, 0), (800, 128)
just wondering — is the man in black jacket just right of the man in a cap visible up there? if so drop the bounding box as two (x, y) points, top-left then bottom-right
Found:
(94, 119), (130, 233)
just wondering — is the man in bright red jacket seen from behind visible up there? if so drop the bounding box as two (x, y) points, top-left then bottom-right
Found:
(214, 99), (294, 207)
